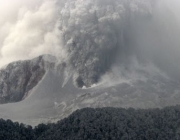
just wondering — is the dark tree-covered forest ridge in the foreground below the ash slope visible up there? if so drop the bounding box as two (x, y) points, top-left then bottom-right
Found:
(0, 106), (180, 140)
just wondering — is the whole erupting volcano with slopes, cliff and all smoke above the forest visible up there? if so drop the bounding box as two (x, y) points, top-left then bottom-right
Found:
(0, 0), (180, 125)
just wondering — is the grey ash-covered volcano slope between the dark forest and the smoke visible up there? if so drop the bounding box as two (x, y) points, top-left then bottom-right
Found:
(0, 57), (180, 126)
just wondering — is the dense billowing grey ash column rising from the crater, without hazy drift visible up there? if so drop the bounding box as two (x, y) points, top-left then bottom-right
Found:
(60, 0), (153, 86)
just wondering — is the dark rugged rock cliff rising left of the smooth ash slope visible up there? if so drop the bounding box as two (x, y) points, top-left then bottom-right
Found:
(0, 55), (56, 104)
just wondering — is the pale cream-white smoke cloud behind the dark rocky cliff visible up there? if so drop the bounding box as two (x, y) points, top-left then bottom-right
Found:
(0, 0), (63, 66)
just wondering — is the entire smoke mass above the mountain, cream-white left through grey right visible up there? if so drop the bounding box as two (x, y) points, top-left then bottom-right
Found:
(0, 0), (180, 87)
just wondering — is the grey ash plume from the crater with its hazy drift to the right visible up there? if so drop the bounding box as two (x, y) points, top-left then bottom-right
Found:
(60, 0), (180, 86)
